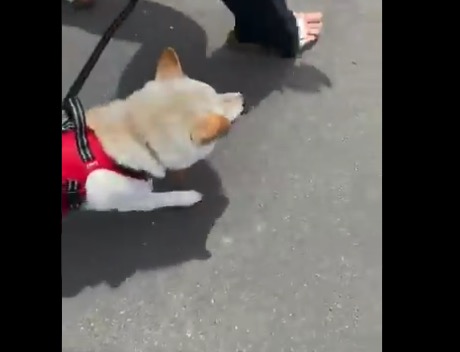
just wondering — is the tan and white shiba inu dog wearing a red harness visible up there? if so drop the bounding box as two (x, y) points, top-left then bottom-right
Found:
(61, 48), (244, 214)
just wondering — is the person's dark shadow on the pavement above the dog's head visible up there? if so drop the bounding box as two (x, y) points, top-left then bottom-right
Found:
(62, 0), (332, 107)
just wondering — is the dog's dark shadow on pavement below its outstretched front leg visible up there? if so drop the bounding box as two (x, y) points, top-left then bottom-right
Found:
(61, 162), (228, 297)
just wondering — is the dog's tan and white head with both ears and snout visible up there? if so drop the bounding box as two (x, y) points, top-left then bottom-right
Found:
(134, 48), (244, 170)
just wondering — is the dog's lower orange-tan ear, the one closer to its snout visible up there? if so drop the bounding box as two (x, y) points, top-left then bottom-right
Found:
(190, 114), (231, 145)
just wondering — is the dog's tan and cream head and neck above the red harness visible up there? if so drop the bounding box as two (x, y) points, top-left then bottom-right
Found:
(86, 48), (243, 177)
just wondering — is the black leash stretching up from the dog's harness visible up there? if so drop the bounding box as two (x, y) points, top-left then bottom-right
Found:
(62, 0), (139, 110)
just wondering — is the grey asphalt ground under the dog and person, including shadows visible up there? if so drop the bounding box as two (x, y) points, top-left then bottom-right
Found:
(62, 0), (382, 352)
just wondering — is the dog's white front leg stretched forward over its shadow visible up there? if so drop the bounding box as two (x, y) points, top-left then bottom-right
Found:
(85, 170), (202, 212)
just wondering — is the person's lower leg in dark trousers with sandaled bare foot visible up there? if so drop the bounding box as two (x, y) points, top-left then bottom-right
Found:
(222, 0), (322, 57)
